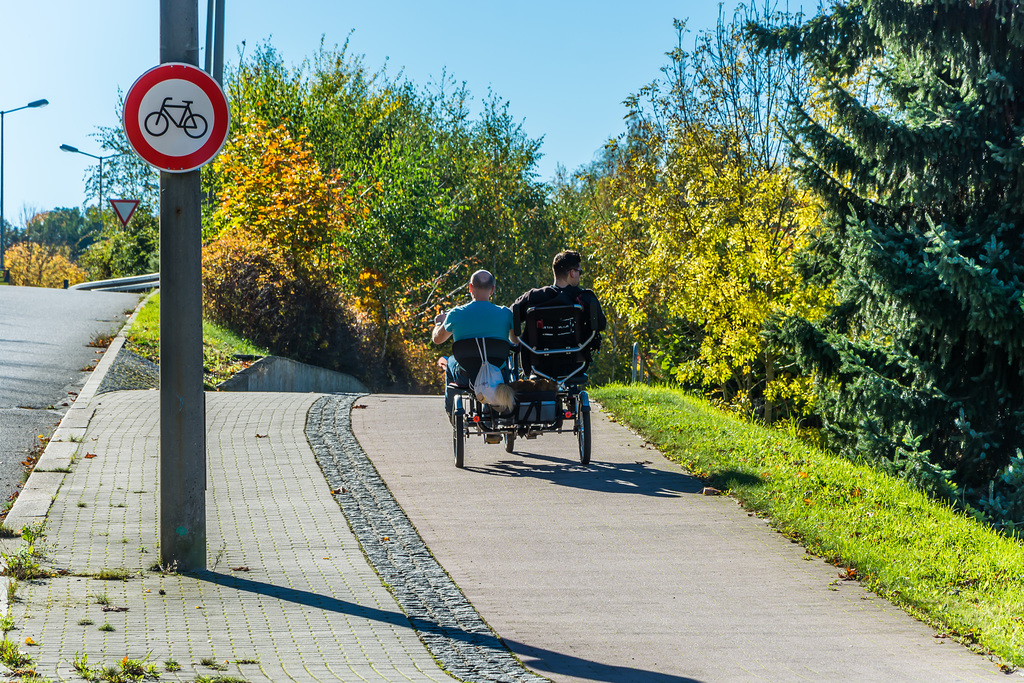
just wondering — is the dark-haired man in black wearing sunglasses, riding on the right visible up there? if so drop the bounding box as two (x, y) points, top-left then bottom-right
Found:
(512, 251), (607, 376)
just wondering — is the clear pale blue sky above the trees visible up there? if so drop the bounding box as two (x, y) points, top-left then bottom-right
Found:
(0, 0), (736, 225)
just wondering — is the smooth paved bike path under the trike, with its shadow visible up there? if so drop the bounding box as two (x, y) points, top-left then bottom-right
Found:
(351, 395), (1007, 683)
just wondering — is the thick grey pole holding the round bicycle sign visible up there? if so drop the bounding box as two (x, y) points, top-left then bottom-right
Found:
(160, 0), (206, 571)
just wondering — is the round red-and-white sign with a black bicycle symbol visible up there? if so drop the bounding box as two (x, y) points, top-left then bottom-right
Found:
(124, 62), (230, 173)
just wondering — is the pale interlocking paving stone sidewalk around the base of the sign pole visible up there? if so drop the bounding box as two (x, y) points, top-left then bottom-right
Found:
(12, 391), (453, 682)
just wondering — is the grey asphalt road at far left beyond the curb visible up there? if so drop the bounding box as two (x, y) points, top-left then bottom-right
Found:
(0, 286), (139, 504)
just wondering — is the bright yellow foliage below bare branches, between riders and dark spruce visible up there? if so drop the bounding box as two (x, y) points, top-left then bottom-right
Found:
(592, 127), (829, 419)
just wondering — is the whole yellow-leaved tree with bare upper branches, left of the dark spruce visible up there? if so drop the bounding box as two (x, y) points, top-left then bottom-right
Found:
(591, 7), (827, 422)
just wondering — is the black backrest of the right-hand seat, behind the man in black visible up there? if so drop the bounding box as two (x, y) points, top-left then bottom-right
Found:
(522, 304), (586, 379)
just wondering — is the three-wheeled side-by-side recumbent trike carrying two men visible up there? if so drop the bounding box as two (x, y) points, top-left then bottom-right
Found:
(449, 304), (597, 468)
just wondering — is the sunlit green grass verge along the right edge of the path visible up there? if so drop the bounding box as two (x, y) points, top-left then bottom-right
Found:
(591, 385), (1024, 667)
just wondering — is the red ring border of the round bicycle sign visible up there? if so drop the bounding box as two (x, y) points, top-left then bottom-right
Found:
(123, 62), (230, 173)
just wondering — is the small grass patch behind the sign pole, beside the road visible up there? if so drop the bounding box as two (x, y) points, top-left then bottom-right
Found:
(126, 293), (269, 387)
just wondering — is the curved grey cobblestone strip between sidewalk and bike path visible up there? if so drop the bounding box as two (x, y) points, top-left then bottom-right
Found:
(306, 394), (548, 683)
